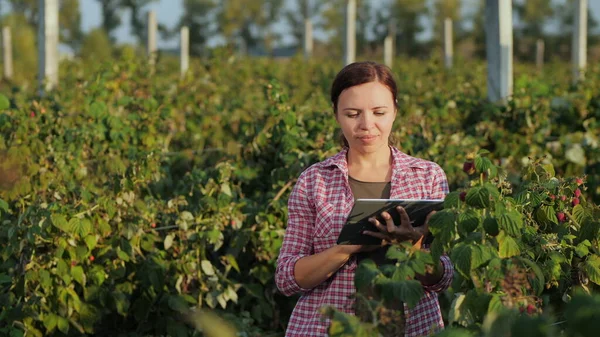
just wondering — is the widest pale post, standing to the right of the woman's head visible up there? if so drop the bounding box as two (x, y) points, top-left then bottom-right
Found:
(485, 0), (513, 102)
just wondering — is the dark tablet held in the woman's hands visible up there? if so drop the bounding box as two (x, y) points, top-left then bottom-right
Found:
(337, 199), (444, 245)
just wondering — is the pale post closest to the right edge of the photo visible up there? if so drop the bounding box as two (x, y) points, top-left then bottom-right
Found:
(571, 0), (587, 82)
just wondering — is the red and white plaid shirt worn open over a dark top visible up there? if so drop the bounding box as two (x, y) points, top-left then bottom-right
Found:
(275, 147), (454, 337)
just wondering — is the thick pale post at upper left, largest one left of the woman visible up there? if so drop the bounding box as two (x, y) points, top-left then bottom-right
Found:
(38, 0), (58, 95)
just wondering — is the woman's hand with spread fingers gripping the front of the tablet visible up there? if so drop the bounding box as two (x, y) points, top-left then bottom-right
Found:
(363, 206), (435, 244)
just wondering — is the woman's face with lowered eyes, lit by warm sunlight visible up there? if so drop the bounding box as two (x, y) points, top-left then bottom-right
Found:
(335, 82), (396, 152)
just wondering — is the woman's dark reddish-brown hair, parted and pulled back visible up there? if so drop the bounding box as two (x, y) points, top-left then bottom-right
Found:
(331, 61), (398, 147)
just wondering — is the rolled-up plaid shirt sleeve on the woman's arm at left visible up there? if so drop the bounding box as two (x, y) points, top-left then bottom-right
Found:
(275, 171), (316, 296)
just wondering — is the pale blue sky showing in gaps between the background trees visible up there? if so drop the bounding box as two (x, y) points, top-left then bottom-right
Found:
(72, 0), (600, 49)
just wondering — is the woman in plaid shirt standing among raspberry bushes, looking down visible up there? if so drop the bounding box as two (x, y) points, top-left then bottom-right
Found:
(275, 62), (453, 337)
